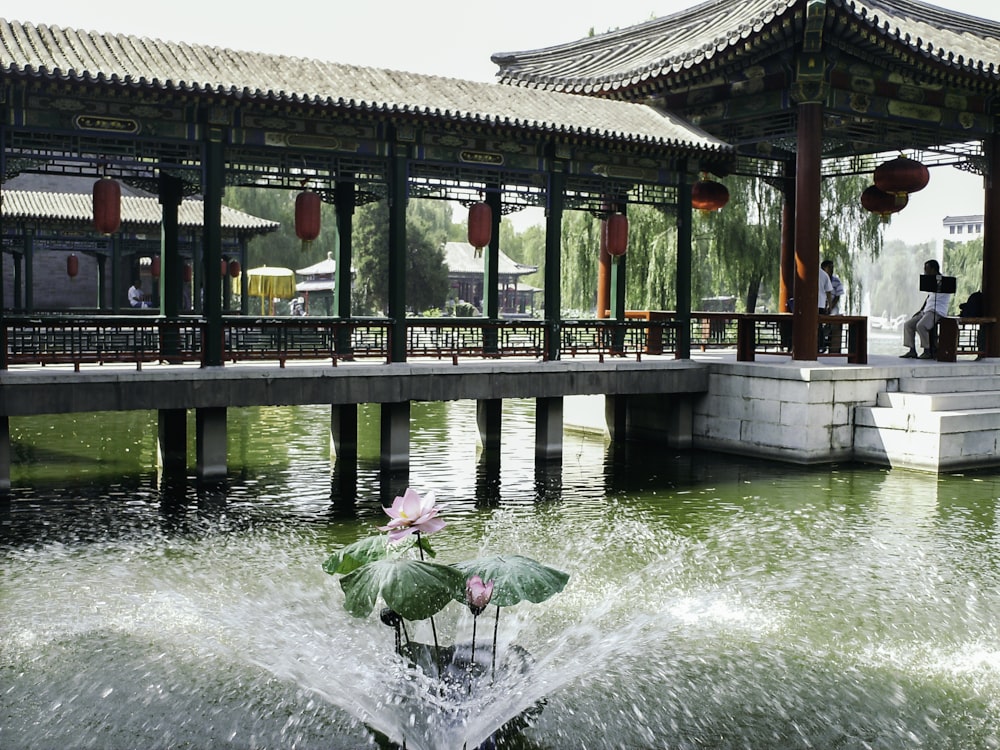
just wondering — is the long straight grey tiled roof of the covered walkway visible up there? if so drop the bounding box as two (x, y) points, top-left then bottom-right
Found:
(0, 19), (729, 151)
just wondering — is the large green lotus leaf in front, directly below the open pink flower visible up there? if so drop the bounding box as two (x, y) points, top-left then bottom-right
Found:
(340, 558), (465, 620)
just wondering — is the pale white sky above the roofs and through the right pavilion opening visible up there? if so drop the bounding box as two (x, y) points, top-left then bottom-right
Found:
(7, 0), (1000, 242)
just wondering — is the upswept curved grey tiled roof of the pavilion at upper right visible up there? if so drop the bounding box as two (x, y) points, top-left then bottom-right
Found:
(492, 0), (1000, 94)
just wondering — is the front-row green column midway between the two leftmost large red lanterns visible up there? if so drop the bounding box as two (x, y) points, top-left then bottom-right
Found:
(202, 125), (225, 367)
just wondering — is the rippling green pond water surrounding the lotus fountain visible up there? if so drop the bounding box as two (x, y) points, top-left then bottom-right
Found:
(0, 401), (1000, 750)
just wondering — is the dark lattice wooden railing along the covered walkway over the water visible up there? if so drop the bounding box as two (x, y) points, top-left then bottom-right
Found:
(0, 315), (677, 370)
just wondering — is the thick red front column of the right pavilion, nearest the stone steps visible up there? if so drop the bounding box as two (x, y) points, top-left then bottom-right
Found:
(792, 102), (823, 362)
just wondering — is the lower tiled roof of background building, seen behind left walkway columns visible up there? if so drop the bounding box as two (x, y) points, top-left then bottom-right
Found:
(3, 188), (280, 234)
